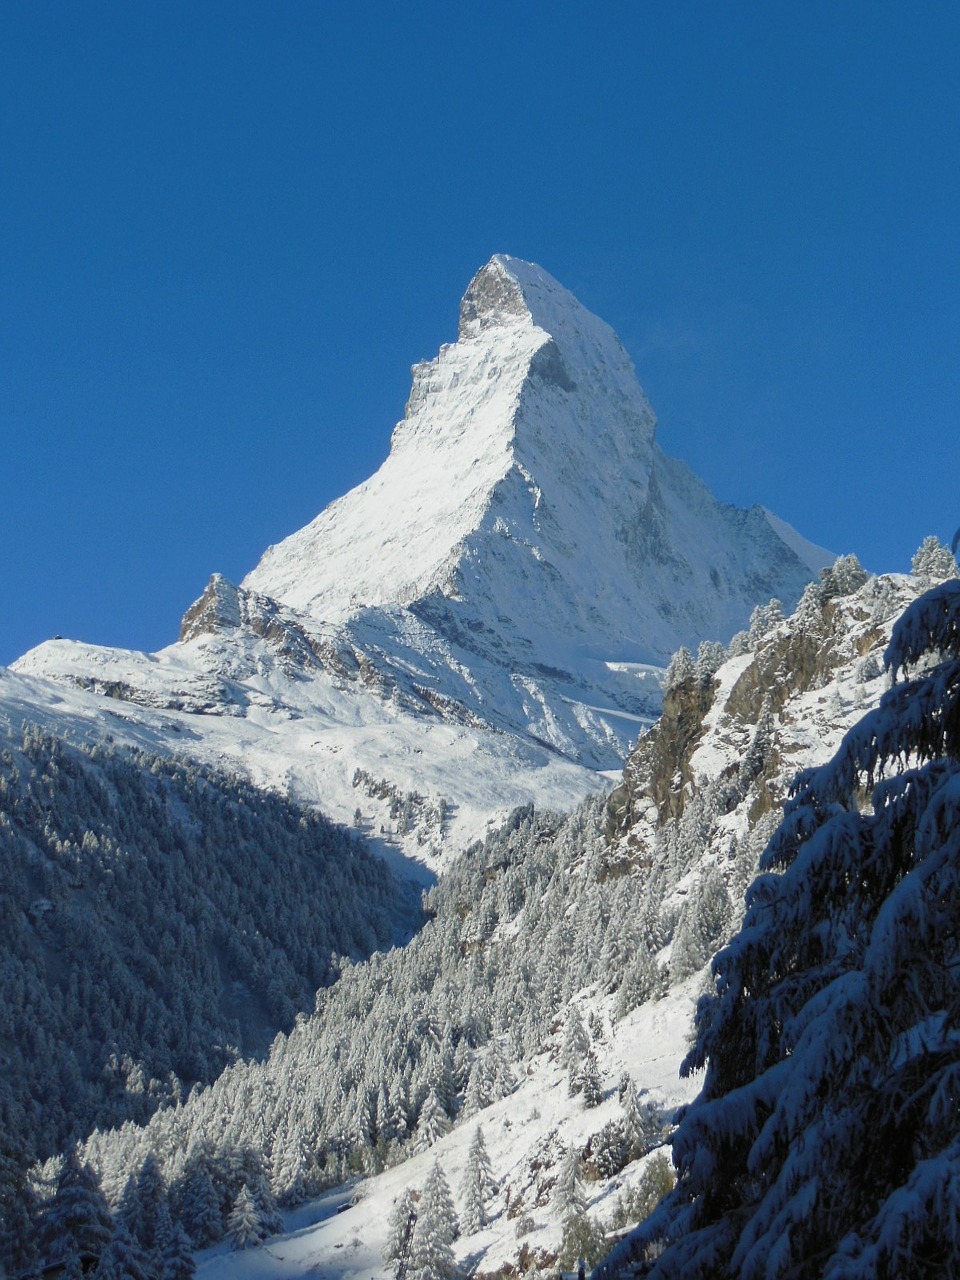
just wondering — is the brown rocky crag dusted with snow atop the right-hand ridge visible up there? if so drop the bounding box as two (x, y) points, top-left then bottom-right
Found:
(607, 571), (916, 856)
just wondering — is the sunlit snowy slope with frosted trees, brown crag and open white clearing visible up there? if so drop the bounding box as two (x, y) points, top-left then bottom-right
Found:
(67, 558), (947, 1280)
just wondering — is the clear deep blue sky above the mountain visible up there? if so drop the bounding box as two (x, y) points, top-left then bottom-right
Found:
(0, 0), (960, 662)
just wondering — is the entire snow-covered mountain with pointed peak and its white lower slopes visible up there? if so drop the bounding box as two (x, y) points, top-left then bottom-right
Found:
(7, 255), (831, 863)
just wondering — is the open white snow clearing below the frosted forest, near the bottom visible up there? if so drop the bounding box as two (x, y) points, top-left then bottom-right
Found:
(197, 975), (703, 1280)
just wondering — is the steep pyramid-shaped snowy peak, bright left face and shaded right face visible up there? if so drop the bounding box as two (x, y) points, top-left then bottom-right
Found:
(243, 255), (831, 711)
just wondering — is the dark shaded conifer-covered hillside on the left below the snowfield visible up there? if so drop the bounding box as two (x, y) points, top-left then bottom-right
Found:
(0, 727), (419, 1157)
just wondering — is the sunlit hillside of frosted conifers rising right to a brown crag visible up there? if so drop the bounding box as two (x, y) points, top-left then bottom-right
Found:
(5, 558), (952, 1266)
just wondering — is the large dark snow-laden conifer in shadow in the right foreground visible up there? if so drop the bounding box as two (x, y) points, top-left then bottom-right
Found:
(602, 581), (960, 1280)
